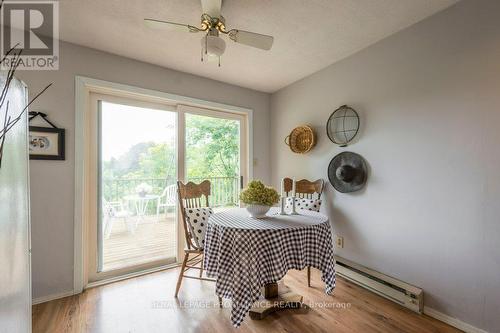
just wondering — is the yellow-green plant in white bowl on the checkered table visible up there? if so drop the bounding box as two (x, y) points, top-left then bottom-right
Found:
(240, 180), (279, 218)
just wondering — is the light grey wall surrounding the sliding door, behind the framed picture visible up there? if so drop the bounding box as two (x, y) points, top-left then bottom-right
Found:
(18, 43), (270, 298)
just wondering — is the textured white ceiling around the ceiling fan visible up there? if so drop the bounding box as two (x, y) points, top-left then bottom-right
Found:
(60, 0), (457, 92)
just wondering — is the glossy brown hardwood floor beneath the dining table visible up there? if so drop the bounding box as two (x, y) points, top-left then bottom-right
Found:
(33, 269), (460, 333)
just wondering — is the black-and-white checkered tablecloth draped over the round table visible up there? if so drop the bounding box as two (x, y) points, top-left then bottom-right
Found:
(204, 208), (335, 327)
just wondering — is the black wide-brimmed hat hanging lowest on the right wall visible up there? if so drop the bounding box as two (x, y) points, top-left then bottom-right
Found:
(328, 151), (367, 193)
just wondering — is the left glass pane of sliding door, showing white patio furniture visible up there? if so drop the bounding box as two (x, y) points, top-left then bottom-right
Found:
(97, 100), (177, 274)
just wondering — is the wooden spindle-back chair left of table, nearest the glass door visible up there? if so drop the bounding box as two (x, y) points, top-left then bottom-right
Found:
(175, 180), (222, 306)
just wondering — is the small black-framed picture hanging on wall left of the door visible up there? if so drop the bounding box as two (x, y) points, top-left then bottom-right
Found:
(29, 126), (65, 160)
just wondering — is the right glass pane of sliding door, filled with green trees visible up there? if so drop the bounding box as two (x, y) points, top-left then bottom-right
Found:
(185, 113), (242, 211)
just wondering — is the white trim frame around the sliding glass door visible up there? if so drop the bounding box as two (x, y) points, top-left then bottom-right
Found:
(73, 76), (253, 294)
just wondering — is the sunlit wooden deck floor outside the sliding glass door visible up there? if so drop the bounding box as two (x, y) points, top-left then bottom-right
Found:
(103, 213), (177, 271)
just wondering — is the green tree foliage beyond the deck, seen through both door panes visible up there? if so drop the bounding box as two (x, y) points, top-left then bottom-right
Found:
(102, 115), (239, 204)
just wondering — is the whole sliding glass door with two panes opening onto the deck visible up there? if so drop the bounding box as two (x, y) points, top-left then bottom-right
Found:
(88, 94), (247, 282)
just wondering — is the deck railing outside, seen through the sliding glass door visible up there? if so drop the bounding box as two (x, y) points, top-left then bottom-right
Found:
(102, 177), (240, 211)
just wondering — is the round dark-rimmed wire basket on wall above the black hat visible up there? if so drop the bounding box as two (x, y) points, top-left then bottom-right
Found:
(326, 105), (359, 147)
